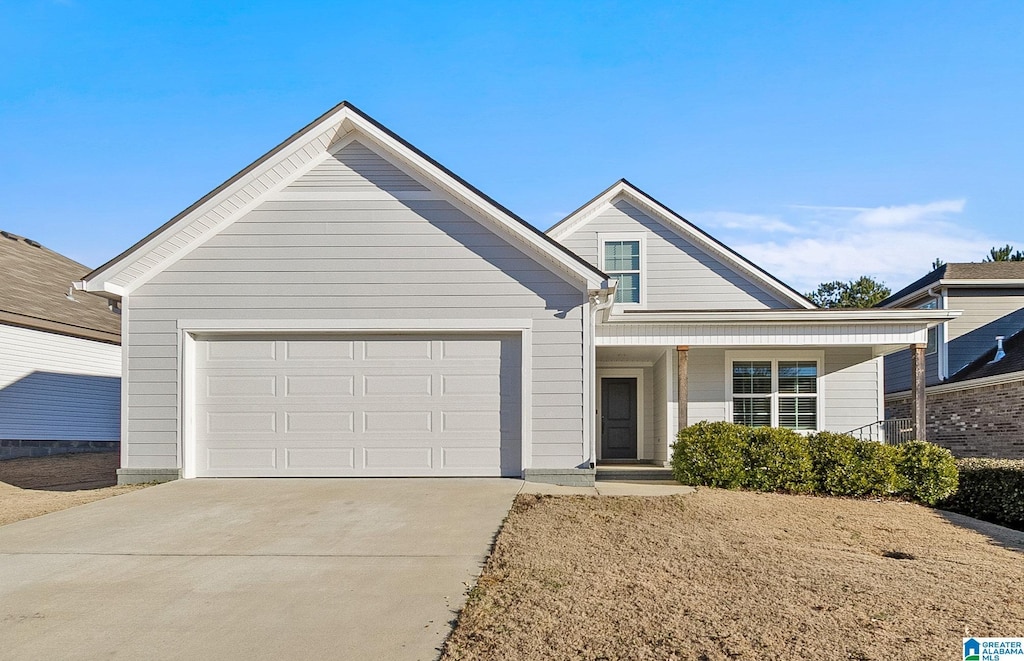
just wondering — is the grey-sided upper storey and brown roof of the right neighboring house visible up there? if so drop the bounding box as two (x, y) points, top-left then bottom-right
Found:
(876, 262), (1024, 393)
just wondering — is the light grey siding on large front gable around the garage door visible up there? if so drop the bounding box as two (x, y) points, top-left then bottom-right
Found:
(125, 143), (587, 468)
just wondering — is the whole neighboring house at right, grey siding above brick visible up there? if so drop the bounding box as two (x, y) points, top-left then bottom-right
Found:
(879, 262), (1024, 458)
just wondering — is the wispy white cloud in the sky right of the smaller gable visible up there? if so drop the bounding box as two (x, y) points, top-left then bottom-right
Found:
(694, 200), (1016, 292)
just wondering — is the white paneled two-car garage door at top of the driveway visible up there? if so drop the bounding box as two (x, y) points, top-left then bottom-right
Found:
(195, 335), (522, 477)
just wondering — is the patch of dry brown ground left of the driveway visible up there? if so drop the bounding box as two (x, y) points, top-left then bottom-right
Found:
(0, 452), (142, 526)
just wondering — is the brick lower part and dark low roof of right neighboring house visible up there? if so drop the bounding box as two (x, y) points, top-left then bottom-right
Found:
(886, 326), (1024, 459)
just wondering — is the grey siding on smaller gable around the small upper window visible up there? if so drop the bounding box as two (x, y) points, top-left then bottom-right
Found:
(561, 201), (790, 310)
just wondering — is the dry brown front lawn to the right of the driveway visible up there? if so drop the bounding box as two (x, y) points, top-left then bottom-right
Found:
(442, 489), (1024, 661)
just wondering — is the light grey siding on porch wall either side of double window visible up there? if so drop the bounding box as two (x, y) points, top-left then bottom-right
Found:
(687, 347), (884, 432)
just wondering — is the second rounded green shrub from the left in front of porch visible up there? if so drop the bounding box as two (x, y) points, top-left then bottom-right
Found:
(742, 427), (814, 493)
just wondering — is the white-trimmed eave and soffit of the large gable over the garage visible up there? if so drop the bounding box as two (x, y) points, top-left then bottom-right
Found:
(76, 101), (608, 298)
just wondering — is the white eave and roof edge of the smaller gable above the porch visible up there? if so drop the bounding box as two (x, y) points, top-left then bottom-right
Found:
(548, 179), (817, 309)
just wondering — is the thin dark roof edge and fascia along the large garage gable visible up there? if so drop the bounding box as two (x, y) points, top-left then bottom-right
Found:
(83, 101), (609, 280)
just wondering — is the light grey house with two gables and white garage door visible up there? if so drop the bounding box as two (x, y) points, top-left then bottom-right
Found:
(76, 102), (957, 484)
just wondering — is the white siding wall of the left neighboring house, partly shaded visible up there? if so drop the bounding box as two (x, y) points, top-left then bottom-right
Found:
(0, 325), (121, 441)
